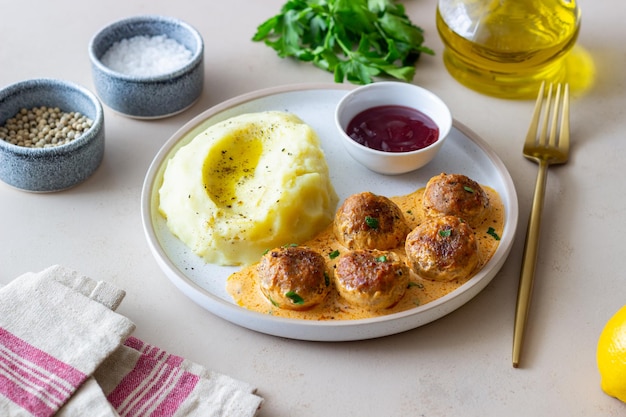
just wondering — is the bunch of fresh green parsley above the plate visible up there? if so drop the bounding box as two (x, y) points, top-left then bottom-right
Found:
(252, 0), (433, 84)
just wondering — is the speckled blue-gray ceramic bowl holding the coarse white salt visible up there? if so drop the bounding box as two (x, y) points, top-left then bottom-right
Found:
(89, 16), (204, 119)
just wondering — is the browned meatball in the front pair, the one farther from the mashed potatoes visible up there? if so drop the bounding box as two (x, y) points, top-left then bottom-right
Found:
(335, 250), (410, 310)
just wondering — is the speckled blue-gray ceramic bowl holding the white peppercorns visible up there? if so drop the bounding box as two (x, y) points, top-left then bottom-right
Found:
(0, 78), (104, 192)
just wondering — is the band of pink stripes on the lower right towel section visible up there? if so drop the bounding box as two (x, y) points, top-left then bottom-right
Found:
(107, 341), (200, 417)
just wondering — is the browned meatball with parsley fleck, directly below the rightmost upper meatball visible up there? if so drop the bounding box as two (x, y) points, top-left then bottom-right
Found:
(405, 216), (479, 281)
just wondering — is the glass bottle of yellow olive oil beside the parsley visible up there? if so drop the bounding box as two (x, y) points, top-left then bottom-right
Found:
(436, 0), (580, 98)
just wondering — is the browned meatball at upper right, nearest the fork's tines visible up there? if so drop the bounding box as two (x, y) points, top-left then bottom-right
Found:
(423, 173), (489, 225)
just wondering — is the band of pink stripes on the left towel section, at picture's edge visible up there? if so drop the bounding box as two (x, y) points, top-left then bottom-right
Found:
(0, 327), (87, 416)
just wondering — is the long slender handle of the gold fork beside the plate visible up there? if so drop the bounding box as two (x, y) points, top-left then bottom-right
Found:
(513, 160), (548, 368)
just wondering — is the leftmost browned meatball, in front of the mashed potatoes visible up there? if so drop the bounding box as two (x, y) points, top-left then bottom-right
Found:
(257, 246), (330, 310)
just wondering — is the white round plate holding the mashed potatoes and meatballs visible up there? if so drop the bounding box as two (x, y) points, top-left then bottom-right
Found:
(141, 84), (518, 341)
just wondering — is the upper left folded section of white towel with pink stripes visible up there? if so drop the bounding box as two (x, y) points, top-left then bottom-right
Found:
(0, 270), (135, 417)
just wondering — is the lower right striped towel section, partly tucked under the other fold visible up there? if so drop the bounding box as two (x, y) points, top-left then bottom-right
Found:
(94, 337), (263, 417)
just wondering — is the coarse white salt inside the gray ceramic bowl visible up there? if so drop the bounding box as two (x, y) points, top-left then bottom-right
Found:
(101, 35), (191, 76)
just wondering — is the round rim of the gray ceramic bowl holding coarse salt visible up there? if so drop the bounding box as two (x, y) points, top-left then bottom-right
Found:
(88, 14), (204, 83)
